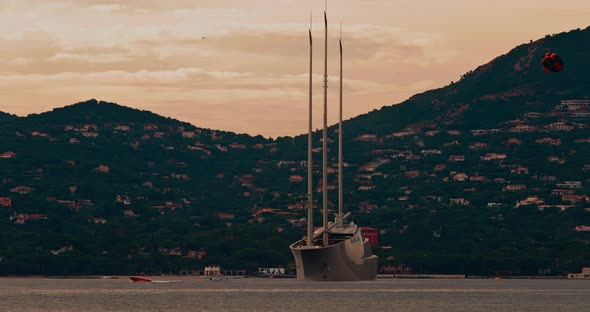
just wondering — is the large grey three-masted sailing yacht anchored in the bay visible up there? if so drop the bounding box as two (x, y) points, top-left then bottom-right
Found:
(290, 12), (377, 281)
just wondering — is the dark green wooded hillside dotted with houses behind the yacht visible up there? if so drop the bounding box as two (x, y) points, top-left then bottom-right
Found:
(0, 29), (590, 275)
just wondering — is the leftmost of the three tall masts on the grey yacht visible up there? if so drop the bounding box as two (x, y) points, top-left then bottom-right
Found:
(307, 25), (313, 246)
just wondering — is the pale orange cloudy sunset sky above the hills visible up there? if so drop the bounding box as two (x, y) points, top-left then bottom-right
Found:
(0, 0), (590, 137)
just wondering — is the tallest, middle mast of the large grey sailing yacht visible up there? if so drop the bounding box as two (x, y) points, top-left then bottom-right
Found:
(322, 9), (328, 246)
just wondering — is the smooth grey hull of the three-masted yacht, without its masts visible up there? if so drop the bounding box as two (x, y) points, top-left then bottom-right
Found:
(291, 229), (377, 281)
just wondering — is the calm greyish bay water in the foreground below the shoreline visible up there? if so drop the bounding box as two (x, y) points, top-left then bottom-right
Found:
(0, 278), (590, 312)
